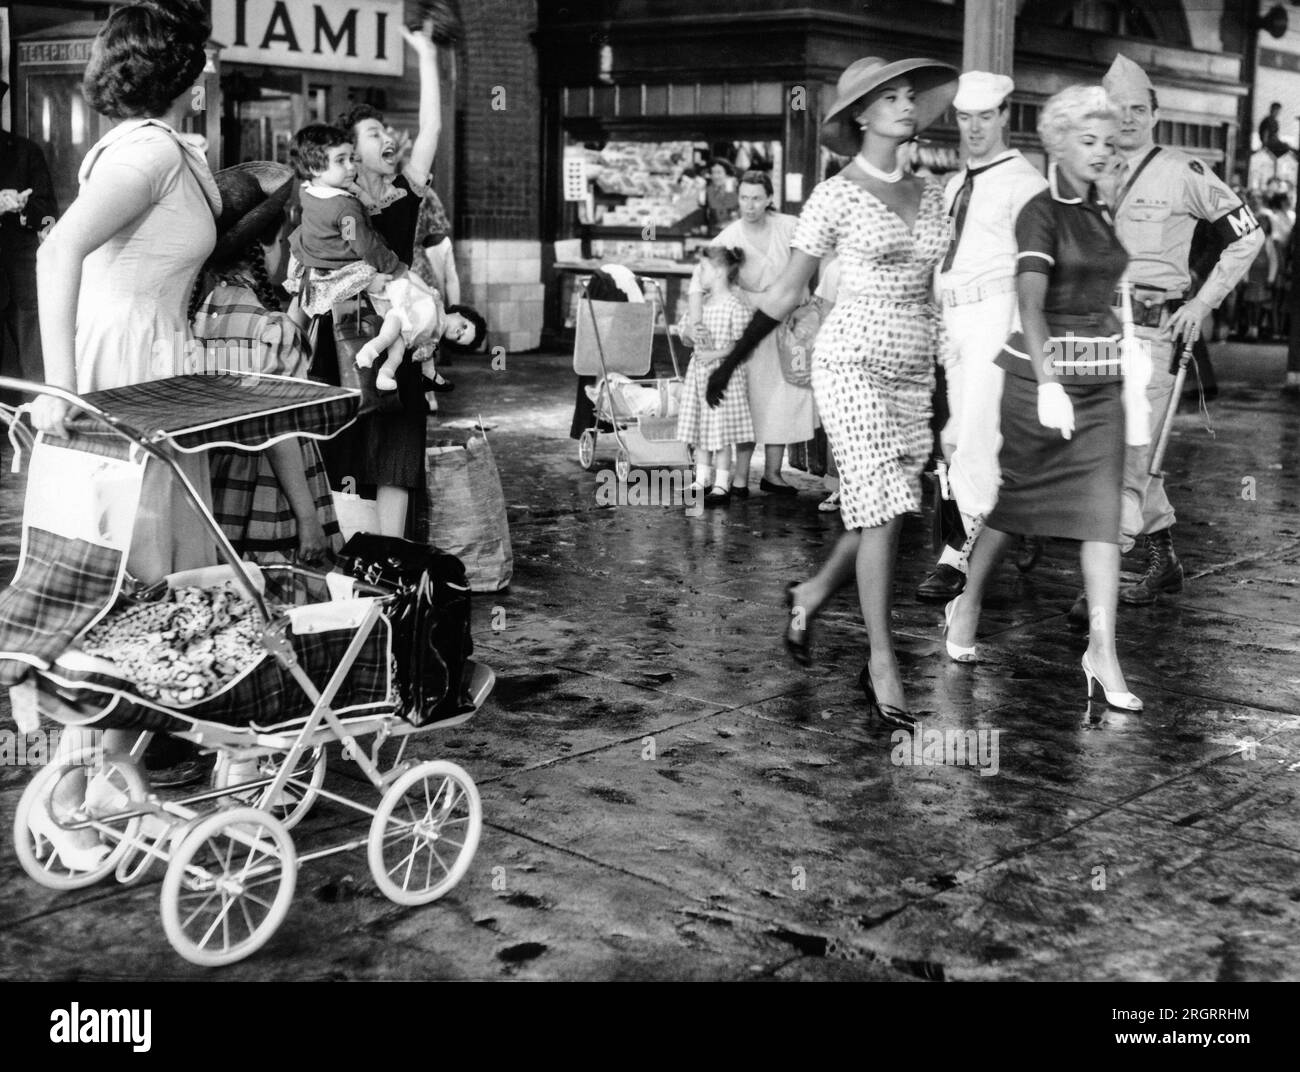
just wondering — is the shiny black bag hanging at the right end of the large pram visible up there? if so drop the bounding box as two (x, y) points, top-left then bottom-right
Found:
(337, 533), (475, 726)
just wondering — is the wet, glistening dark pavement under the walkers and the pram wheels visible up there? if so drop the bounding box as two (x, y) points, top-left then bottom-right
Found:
(0, 347), (1300, 981)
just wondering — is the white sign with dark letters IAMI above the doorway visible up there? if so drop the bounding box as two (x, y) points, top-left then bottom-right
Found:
(212, 0), (403, 75)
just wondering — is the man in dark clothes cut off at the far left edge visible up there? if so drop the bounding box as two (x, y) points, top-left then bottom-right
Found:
(0, 82), (59, 382)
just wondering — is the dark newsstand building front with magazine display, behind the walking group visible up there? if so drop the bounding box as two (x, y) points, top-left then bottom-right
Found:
(537, 0), (1247, 327)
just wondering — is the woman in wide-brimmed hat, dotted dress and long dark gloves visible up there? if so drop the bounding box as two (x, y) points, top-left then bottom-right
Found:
(710, 57), (957, 725)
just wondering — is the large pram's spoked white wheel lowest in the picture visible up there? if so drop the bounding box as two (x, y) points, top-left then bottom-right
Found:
(163, 807), (298, 968)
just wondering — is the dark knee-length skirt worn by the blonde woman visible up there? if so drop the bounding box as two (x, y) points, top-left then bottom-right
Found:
(987, 373), (1125, 543)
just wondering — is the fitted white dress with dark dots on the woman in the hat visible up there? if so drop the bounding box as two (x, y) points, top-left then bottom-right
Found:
(792, 175), (949, 529)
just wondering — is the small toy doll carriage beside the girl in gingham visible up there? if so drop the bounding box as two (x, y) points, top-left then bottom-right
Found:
(573, 270), (690, 481)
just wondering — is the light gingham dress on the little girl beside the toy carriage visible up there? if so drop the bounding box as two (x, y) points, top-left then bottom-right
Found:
(677, 294), (754, 451)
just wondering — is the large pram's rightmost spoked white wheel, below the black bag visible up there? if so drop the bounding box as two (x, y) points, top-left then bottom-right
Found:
(368, 759), (482, 904)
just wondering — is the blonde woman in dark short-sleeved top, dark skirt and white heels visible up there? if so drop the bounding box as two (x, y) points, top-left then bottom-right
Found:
(945, 86), (1143, 711)
